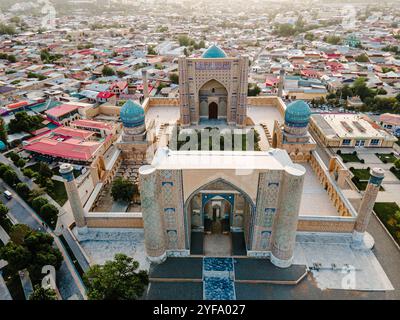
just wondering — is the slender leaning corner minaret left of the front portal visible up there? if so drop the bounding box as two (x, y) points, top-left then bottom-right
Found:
(60, 163), (87, 234)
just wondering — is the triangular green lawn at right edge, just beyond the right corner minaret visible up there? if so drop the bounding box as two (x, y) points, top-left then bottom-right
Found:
(374, 202), (400, 244)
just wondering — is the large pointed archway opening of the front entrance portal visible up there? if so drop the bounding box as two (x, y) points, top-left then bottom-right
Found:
(185, 178), (254, 256)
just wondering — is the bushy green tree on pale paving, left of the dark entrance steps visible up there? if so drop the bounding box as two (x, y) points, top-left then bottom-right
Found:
(83, 254), (148, 300)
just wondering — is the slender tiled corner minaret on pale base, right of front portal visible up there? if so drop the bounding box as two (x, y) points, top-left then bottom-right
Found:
(352, 168), (385, 249)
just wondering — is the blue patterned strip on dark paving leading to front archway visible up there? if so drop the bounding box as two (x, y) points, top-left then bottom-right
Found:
(203, 258), (236, 300)
